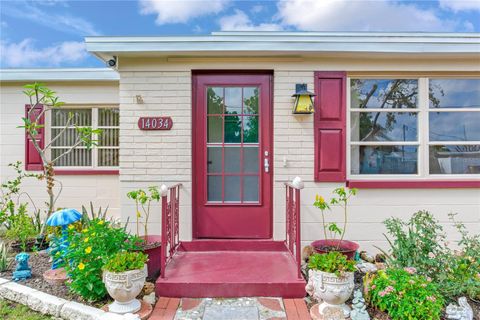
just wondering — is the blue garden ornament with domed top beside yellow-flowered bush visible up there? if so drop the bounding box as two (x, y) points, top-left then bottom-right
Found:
(46, 209), (82, 270)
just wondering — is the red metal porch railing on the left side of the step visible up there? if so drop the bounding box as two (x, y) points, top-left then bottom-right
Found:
(160, 183), (182, 278)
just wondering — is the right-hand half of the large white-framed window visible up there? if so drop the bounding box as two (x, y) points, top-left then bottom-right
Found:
(428, 79), (480, 175)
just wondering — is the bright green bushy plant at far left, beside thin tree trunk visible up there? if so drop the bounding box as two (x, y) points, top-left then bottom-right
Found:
(5, 204), (37, 251)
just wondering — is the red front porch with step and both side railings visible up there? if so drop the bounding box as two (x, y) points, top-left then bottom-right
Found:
(155, 178), (305, 298)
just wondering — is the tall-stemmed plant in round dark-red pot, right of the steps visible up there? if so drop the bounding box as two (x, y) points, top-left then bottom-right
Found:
(311, 187), (359, 259)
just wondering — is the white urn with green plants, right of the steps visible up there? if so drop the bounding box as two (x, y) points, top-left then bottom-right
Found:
(305, 251), (355, 317)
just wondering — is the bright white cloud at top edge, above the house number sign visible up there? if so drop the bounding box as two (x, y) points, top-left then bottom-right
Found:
(140, 0), (229, 25)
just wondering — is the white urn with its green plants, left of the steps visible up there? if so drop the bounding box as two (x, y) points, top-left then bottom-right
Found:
(103, 251), (148, 314)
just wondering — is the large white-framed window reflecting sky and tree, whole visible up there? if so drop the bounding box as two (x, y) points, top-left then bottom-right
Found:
(348, 77), (480, 178)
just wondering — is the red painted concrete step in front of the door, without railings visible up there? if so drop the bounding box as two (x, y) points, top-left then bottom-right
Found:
(155, 240), (305, 298)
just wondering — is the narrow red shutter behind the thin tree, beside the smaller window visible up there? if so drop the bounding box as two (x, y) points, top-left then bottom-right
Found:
(25, 104), (45, 170)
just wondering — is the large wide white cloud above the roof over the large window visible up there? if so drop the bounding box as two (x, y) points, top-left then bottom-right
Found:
(277, 0), (465, 31)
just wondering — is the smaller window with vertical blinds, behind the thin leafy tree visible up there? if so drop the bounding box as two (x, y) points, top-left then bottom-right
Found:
(50, 108), (120, 169)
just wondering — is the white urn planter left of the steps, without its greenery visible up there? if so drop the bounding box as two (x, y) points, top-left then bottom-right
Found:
(103, 264), (147, 314)
